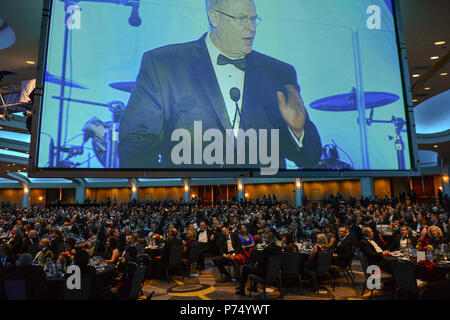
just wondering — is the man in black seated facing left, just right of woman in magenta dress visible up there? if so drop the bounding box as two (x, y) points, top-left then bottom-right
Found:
(236, 232), (282, 296)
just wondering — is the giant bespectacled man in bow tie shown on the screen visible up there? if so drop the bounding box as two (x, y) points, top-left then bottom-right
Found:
(118, 0), (322, 168)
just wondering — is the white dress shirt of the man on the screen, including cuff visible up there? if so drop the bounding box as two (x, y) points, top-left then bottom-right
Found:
(205, 32), (305, 148)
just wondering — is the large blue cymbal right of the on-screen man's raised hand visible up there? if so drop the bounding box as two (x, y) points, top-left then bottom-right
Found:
(310, 91), (400, 111)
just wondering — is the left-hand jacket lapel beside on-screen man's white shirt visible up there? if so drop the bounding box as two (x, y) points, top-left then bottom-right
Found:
(193, 34), (231, 129)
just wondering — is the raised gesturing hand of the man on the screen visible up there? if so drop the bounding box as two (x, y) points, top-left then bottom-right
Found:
(277, 85), (306, 139)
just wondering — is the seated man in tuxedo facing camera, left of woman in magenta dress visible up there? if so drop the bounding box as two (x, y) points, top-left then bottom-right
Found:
(213, 227), (242, 282)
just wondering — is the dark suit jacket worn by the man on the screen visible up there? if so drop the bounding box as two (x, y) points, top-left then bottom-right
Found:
(118, 34), (322, 168)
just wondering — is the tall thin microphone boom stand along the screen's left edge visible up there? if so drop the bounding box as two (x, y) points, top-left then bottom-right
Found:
(54, 0), (140, 168)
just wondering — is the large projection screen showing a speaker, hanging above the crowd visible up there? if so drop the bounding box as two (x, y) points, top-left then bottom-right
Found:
(30, 0), (416, 177)
